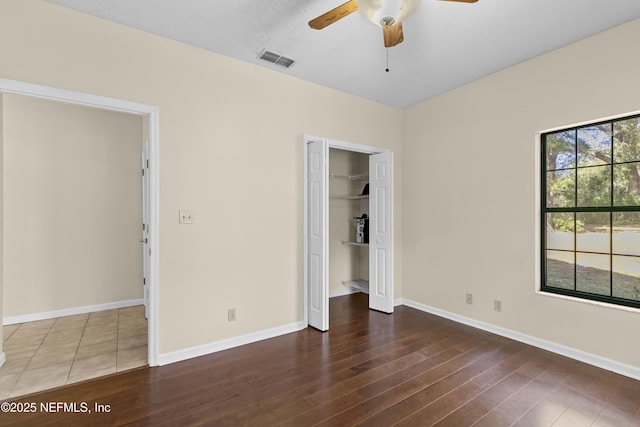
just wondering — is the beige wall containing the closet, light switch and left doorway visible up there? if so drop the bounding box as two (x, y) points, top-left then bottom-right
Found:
(0, 0), (402, 353)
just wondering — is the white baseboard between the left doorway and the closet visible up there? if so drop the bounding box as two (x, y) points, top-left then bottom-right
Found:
(158, 322), (307, 366)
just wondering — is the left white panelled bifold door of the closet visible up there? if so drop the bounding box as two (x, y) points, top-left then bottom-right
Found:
(307, 140), (329, 331)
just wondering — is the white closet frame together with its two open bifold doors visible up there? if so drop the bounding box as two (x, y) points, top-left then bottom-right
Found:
(303, 135), (393, 331)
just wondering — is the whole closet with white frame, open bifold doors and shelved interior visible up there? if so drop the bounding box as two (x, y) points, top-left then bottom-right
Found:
(302, 135), (393, 331)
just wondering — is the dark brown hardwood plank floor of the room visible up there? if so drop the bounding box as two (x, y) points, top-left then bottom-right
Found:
(0, 294), (640, 427)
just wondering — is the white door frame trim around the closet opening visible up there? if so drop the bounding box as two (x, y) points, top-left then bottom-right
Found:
(302, 134), (394, 325)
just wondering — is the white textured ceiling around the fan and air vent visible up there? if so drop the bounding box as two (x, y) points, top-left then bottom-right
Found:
(49, 0), (640, 108)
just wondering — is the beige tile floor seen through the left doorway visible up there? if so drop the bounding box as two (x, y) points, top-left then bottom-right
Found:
(0, 306), (147, 399)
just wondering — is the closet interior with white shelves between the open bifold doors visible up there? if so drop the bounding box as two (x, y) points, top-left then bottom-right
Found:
(329, 148), (370, 297)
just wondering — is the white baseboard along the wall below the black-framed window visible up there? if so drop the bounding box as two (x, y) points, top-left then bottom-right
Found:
(402, 299), (640, 380)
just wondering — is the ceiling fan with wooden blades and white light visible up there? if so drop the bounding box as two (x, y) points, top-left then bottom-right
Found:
(309, 0), (478, 47)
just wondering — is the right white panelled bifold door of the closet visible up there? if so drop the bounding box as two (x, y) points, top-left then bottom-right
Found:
(369, 152), (393, 313)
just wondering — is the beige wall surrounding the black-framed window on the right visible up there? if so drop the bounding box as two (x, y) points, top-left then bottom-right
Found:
(403, 20), (640, 367)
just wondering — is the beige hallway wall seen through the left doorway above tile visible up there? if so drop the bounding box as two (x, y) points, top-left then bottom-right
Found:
(3, 94), (142, 317)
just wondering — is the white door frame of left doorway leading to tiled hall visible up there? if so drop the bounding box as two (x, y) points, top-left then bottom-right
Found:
(0, 78), (160, 366)
